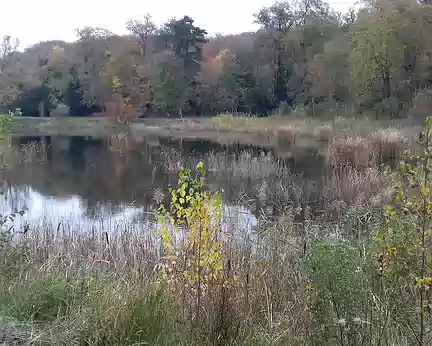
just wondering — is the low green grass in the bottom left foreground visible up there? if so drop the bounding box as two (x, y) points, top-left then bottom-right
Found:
(0, 273), (191, 345)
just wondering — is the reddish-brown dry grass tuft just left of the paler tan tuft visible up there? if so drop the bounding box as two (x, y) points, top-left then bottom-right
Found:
(326, 138), (373, 167)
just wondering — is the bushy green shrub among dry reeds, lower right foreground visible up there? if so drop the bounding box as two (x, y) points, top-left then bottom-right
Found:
(307, 242), (370, 345)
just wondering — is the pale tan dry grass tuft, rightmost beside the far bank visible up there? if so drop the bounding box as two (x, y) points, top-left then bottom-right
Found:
(372, 129), (406, 158)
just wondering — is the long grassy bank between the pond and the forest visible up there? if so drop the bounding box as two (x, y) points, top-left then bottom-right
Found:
(3, 114), (419, 146)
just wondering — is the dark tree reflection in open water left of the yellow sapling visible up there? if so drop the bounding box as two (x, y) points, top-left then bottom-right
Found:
(9, 137), (170, 214)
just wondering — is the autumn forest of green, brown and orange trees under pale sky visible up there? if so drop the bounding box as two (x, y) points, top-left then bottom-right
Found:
(0, 0), (432, 117)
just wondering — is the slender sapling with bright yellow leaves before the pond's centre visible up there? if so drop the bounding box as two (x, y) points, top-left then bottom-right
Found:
(158, 162), (227, 316)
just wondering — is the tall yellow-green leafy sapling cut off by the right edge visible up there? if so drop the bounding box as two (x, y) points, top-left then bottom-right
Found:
(376, 117), (432, 345)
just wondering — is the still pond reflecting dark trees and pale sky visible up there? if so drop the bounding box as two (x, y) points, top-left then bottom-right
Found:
(0, 135), (326, 235)
